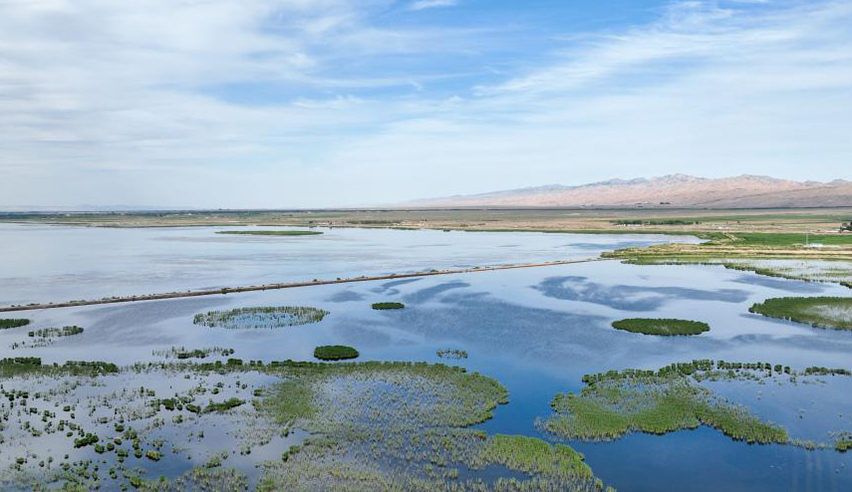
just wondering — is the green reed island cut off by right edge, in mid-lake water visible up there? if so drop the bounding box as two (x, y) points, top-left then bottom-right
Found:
(749, 297), (852, 330)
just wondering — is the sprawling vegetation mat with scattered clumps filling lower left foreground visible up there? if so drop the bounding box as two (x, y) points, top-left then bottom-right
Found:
(0, 359), (603, 492)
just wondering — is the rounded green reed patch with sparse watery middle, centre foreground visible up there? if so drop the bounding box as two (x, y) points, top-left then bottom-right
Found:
(265, 361), (508, 432)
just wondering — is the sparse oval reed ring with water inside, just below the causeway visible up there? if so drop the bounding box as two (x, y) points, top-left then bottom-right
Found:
(192, 306), (328, 329)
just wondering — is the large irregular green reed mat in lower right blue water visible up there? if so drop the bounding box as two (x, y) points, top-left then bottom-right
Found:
(537, 360), (850, 448)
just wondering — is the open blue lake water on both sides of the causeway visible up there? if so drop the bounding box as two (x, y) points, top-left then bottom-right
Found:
(0, 226), (852, 491)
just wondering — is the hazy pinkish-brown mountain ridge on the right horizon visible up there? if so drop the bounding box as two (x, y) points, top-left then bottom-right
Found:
(400, 174), (852, 208)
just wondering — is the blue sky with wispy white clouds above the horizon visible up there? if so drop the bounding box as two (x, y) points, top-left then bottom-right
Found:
(0, 0), (852, 208)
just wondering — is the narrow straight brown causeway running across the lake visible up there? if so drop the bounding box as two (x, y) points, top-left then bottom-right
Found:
(0, 258), (616, 313)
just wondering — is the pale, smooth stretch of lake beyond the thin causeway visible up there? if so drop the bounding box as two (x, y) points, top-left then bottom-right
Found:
(0, 224), (697, 305)
